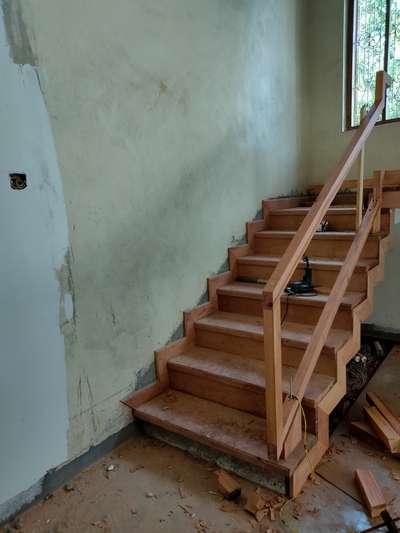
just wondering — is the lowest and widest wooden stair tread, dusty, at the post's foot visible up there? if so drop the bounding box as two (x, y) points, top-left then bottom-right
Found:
(134, 390), (312, 473)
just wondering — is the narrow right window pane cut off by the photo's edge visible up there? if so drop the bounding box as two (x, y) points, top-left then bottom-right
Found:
(386, 0), (400, 119)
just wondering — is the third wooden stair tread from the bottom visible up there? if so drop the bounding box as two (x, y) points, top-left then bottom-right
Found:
(195, 311), (351, 353)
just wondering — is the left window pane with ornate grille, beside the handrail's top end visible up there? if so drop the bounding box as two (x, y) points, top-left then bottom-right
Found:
(352, 0), (386, 126)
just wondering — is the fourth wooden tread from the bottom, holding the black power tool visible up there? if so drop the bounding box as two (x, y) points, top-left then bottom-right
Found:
(218, 281), (366, 309)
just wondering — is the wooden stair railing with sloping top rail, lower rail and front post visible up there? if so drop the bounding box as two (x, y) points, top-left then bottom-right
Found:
(263, 71), (391, 458)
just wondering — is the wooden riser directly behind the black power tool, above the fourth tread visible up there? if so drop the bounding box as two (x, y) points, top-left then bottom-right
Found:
(237, 262), (368, 292)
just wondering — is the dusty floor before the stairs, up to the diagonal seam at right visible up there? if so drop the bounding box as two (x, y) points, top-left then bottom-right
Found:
(0, 436), (382, 533)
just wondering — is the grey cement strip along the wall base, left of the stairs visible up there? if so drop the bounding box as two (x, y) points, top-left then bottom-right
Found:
(0, 422), (138, 526)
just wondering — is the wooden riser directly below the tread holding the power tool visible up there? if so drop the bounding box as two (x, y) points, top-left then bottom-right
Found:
(218, 294), (353, 329)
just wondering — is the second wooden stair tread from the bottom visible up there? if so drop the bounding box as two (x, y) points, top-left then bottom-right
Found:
(168, 346), (334, 407)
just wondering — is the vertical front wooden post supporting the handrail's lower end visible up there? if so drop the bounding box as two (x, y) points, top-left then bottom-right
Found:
(264, 297), (283, 459)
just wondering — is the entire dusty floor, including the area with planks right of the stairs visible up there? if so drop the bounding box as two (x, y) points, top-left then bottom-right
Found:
(5, 346), (400, 533)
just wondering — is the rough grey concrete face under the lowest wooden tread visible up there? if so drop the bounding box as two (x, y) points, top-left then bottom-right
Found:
(142, 421), (288, 496)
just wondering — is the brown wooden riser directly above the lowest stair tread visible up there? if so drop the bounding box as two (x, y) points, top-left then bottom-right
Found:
(168, 366), (316, 434)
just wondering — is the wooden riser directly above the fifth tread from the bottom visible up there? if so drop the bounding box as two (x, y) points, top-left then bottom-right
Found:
(254, 235), (379, 259)
